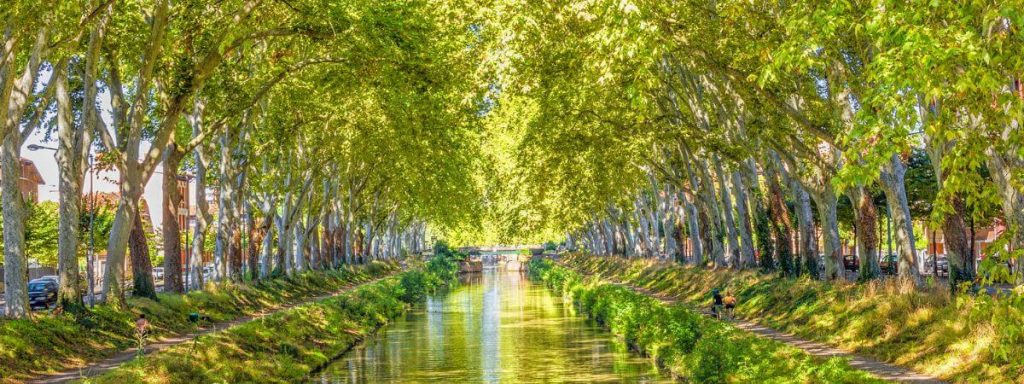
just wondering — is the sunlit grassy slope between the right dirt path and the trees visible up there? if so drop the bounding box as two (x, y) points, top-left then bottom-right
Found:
(565, 255), (1024, 383)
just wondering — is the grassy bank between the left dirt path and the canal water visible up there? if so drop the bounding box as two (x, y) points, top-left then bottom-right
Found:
(81, 258), (456, 384)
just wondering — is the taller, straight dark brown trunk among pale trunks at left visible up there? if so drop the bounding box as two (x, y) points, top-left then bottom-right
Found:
(162, 147), (185, 293)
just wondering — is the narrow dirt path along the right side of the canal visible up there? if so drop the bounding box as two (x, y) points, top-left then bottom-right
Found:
(559, 263), (945, 384)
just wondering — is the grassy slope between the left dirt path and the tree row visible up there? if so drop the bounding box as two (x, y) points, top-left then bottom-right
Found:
(0, 263), (397, 382)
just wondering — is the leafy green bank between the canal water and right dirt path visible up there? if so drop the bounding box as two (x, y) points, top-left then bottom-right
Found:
(529, 260), (882, 383)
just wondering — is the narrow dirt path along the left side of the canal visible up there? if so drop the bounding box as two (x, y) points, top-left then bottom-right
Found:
(26, 270), (400, 384)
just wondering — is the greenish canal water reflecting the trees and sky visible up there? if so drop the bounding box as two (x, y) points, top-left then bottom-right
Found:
(310, 267), (669, 384)
